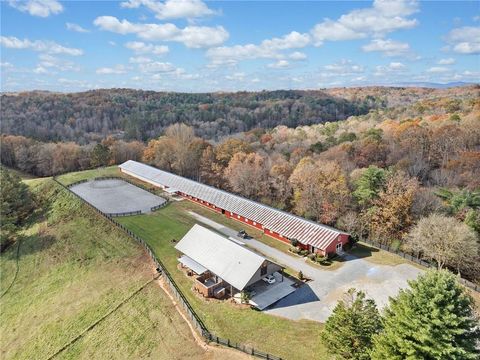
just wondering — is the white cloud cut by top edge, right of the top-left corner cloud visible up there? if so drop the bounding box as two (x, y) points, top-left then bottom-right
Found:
(120, 0), (215, 20)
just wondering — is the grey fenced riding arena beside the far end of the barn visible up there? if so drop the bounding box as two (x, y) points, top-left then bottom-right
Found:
(70, 179), (166, 216)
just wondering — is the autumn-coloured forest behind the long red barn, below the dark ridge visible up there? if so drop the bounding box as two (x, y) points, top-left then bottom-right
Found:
(1, 87), (480, 282)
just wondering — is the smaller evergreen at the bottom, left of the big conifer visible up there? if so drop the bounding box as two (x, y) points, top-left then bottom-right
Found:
(322, 289), (381, 360)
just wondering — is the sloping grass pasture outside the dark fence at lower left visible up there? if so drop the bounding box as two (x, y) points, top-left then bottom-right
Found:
(0, 179), (211, 359)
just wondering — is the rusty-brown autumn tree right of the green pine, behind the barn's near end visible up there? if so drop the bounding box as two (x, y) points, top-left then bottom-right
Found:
(363, 172), (418, 245)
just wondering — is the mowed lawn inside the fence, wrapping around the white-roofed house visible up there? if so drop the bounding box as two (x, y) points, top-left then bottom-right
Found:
(118, 201), (330, 359)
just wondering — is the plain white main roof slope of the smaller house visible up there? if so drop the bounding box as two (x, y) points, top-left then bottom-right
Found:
(175, 224), (268, 290)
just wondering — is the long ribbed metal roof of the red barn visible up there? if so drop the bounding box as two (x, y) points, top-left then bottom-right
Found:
(119, 160), (348, 249)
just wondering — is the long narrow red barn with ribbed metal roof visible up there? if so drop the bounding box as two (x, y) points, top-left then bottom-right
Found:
(119, 160), (349, 255)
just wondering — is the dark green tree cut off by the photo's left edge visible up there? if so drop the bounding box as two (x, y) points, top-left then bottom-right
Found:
(0, 168), (33, 250)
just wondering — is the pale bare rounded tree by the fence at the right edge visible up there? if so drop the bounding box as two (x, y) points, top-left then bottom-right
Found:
(405, 214), (480, 271)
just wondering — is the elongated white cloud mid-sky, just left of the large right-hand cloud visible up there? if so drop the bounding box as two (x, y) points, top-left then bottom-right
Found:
(207, 31), (310, 66)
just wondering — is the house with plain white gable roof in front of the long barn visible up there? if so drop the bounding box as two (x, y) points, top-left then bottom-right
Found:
(175, 224), (283, 298)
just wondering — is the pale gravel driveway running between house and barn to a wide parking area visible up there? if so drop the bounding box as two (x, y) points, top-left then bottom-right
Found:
(189, 211), (422, 322)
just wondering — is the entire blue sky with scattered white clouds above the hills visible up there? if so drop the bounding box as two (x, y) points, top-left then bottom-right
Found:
(0, 0), (480, 92)
